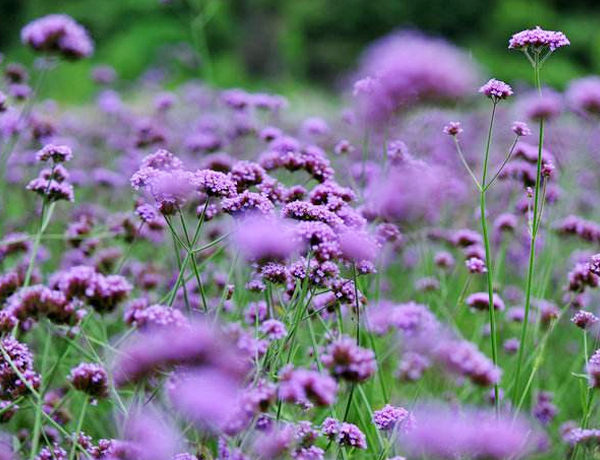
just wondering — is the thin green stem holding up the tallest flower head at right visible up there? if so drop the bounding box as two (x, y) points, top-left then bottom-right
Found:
(512, 53), (544, 401)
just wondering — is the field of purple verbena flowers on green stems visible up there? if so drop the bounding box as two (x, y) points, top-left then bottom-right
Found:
(0, 8), (600, 460)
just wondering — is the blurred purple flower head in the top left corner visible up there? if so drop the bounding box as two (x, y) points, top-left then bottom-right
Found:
(21, 14), (94, 60)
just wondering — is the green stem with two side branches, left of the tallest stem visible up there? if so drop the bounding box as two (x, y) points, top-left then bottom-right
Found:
(479, 101), (500, 413)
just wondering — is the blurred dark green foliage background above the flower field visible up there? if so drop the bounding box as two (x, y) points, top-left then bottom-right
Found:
(0, 0), (600, 102)
